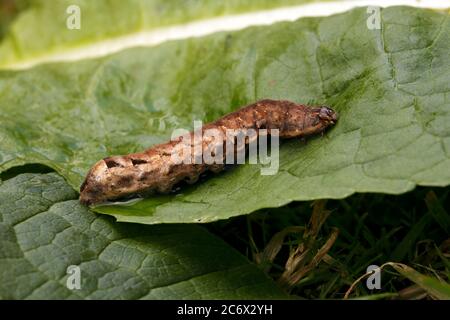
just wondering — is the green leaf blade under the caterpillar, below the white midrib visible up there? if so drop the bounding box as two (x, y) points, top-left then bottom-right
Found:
(0, 7), (450, 224)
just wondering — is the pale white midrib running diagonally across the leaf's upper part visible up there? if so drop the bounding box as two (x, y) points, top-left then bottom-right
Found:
(7, 0), (450, 69)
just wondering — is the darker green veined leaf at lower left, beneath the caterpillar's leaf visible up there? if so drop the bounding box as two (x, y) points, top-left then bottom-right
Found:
(0, 173), (286, 299)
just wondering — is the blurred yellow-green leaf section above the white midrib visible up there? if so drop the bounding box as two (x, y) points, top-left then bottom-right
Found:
(0, 0), (318, 68)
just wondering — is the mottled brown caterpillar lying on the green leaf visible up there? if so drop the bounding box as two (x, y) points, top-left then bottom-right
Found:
(80, 100), (338, 205)
